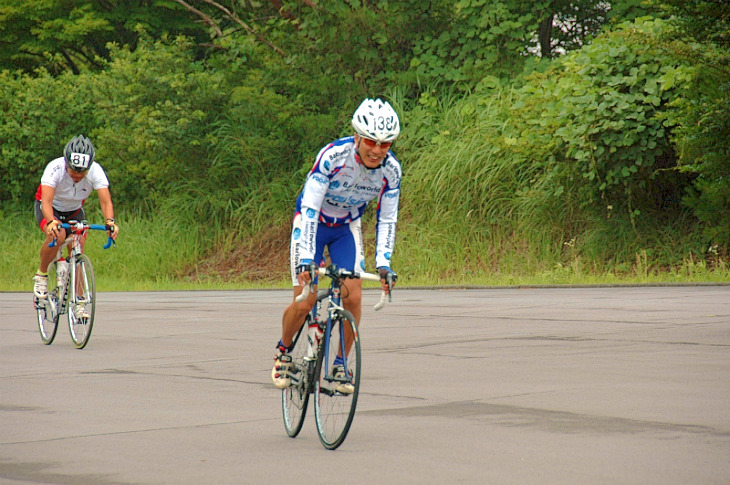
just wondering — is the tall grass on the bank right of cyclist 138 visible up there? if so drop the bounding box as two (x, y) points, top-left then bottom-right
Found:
(386, 86), (728, 284)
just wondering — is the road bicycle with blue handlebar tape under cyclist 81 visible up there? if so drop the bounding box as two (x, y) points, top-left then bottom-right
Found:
(33, 221), (114, 349)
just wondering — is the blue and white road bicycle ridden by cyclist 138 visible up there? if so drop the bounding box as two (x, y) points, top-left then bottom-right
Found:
(281, 265), (393, 450)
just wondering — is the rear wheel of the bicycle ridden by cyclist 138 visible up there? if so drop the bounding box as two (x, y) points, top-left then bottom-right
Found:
(281, 316), (315, 438)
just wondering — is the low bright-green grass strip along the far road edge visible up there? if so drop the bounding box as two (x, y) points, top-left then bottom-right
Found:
(0, 208), (730, 291)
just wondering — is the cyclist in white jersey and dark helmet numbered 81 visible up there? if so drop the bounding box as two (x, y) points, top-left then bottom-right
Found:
(33, 135), (119, 299)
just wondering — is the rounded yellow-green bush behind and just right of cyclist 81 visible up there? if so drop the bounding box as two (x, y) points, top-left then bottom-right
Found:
(93, 38), (229, 206)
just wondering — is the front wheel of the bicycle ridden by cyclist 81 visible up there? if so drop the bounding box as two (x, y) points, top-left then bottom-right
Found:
(68, 254), (96, 349)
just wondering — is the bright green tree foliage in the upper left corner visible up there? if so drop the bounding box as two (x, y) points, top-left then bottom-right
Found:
(0, 0), (205, 74)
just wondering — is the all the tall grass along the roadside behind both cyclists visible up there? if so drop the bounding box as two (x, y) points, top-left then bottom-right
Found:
(0, 86), (730, 291)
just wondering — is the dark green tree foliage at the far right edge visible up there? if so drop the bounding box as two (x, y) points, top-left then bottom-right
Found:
(659, 0), (730, 242)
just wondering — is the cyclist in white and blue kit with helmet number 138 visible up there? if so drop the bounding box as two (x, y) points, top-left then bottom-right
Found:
(271, 99), (401, 392)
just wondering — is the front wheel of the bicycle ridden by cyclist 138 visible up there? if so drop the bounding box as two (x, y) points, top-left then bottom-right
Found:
(314, 310), (360, 450)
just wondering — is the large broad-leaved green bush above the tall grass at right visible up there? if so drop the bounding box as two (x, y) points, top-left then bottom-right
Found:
(514, 20), (694, 220)
